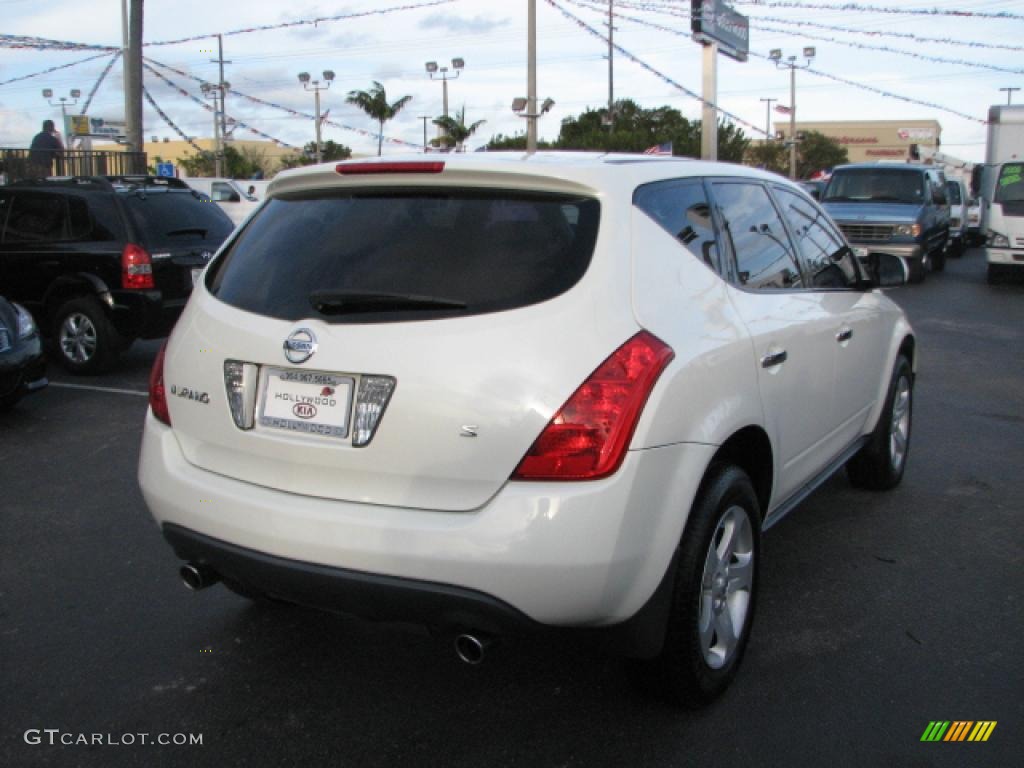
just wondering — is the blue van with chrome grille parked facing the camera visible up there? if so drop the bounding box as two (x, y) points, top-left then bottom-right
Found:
(821, 163), (949, 282)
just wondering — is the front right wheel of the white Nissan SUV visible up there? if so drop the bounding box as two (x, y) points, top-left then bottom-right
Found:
(846, 354), (913, 490)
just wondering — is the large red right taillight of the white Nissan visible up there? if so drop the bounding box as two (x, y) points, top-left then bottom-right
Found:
(512, 331), (676, 480)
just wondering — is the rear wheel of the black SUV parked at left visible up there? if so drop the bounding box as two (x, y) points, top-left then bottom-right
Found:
(53, 297), (125, 374)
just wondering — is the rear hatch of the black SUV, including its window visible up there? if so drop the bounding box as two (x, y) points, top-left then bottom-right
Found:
(121, 187), (233, 300)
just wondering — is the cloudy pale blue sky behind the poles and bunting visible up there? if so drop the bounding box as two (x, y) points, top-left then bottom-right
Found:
(0, 0), (1024, 161)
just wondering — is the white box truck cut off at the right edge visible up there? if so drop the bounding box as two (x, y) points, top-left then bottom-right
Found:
(981, 104), (1024, 283)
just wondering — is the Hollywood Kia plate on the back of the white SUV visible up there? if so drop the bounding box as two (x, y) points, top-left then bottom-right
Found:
(259, 368), (353, 437)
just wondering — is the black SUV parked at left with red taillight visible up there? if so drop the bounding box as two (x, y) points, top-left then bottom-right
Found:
(0, 176), (233, 374)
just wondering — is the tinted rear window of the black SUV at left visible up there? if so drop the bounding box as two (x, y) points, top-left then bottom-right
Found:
(122, 189), (234, 246)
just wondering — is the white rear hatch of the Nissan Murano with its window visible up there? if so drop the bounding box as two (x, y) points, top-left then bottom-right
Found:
(165, 174), (637, 510)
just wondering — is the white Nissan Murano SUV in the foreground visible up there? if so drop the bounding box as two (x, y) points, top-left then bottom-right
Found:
(139, 153), (915, 700)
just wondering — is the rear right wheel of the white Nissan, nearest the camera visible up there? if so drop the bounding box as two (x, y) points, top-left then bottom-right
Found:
(654, 466), (761, 705)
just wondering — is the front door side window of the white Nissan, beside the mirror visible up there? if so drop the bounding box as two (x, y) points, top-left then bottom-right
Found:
(773, 186), (858, 288)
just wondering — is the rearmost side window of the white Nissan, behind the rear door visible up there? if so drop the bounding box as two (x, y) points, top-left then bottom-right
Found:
(633, 180), (718, 269)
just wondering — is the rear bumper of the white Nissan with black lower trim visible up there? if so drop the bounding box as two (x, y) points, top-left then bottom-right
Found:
(139, 414), (715, 629)
